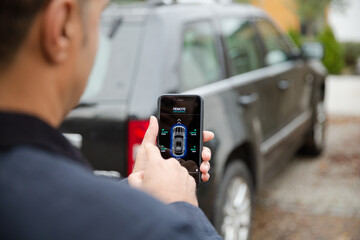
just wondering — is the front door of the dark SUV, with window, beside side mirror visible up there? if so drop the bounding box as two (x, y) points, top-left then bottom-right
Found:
(254, 18), (307, 177)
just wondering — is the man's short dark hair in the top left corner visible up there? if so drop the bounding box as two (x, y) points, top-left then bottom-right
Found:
(0, 0), (51, 66)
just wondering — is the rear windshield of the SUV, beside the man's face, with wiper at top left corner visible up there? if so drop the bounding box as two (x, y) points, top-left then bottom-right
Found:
(80, 16), (142, 103)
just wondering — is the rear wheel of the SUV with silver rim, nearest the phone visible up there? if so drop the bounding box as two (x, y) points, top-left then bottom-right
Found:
(215, 161), (253, 240)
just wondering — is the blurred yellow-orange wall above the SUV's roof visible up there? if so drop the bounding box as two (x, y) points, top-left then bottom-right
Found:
(250, 0), (300, 32)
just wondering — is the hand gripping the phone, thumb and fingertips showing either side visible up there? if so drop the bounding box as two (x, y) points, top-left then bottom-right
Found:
(133, 116), (214, 182)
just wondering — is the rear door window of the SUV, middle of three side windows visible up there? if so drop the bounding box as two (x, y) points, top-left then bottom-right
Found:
(221, 18), (261, 76)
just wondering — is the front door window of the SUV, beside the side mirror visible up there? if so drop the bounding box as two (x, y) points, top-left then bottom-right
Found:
(256, 19), (291, 65)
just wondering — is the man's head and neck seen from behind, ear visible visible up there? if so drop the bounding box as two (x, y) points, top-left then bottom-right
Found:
(0, 0), (108, 125)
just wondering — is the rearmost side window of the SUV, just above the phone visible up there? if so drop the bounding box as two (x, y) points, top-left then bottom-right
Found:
(180, 21), (221, 90)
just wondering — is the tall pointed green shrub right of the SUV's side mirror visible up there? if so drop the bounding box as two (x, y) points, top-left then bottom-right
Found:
(318, 26), (344, 74)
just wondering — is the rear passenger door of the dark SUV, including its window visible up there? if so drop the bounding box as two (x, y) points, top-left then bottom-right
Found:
(221, 17), (278, 146)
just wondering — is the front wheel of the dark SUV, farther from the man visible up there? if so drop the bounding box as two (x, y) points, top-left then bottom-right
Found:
(301, 97), (327, 157)
